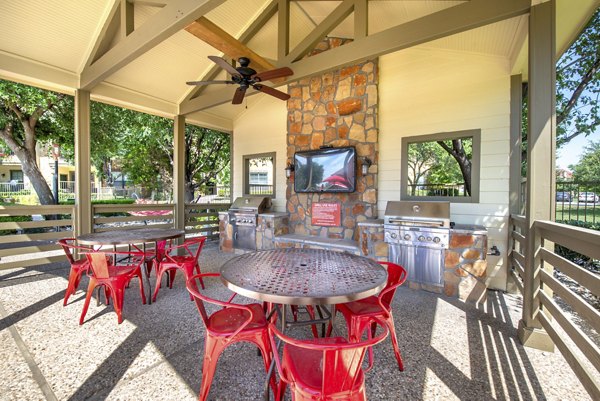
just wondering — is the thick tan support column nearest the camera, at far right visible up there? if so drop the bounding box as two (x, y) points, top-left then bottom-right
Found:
(518, 0), (556, 351)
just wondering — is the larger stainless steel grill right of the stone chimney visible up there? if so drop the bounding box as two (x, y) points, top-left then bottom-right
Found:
(384, 201), (450, 287)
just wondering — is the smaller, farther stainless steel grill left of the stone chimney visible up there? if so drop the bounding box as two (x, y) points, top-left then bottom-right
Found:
(228, 196), (271, 250)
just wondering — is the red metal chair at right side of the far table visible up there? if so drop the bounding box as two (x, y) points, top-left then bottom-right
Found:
(152, 237), (206, 302)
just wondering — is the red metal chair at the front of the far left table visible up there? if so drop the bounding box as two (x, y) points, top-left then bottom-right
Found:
(79, 252), (146, 325)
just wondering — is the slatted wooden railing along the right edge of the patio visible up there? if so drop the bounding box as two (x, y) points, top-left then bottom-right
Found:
(509, 216), (600, 400)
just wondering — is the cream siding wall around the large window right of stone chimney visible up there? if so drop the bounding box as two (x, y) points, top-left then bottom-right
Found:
(378, 46), (510, 289)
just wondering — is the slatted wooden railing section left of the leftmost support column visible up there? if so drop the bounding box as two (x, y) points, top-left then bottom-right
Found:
(0, 206), (74, 270)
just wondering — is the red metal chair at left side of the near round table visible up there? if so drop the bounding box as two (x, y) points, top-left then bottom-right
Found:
(186, 273), (276, 401)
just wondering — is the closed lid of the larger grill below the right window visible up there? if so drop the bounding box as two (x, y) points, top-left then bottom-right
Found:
(384, 201), (450, 227)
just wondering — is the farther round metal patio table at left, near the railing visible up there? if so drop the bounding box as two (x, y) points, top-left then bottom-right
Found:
(77, 228), (185, 303)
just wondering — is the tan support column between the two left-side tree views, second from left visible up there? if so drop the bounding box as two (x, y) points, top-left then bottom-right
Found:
(173, 115), (186, 230)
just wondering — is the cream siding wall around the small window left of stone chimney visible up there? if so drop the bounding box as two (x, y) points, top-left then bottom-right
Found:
(232, 95), (287, 212)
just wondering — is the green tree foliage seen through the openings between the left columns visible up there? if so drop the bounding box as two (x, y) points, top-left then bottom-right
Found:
(0, 80), (230, 204)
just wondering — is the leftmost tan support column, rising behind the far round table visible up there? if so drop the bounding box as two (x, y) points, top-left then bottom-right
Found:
(74, 89), (92, 236)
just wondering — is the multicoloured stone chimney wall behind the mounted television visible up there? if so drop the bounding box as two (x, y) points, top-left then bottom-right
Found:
(286, 38), (378, 241)
